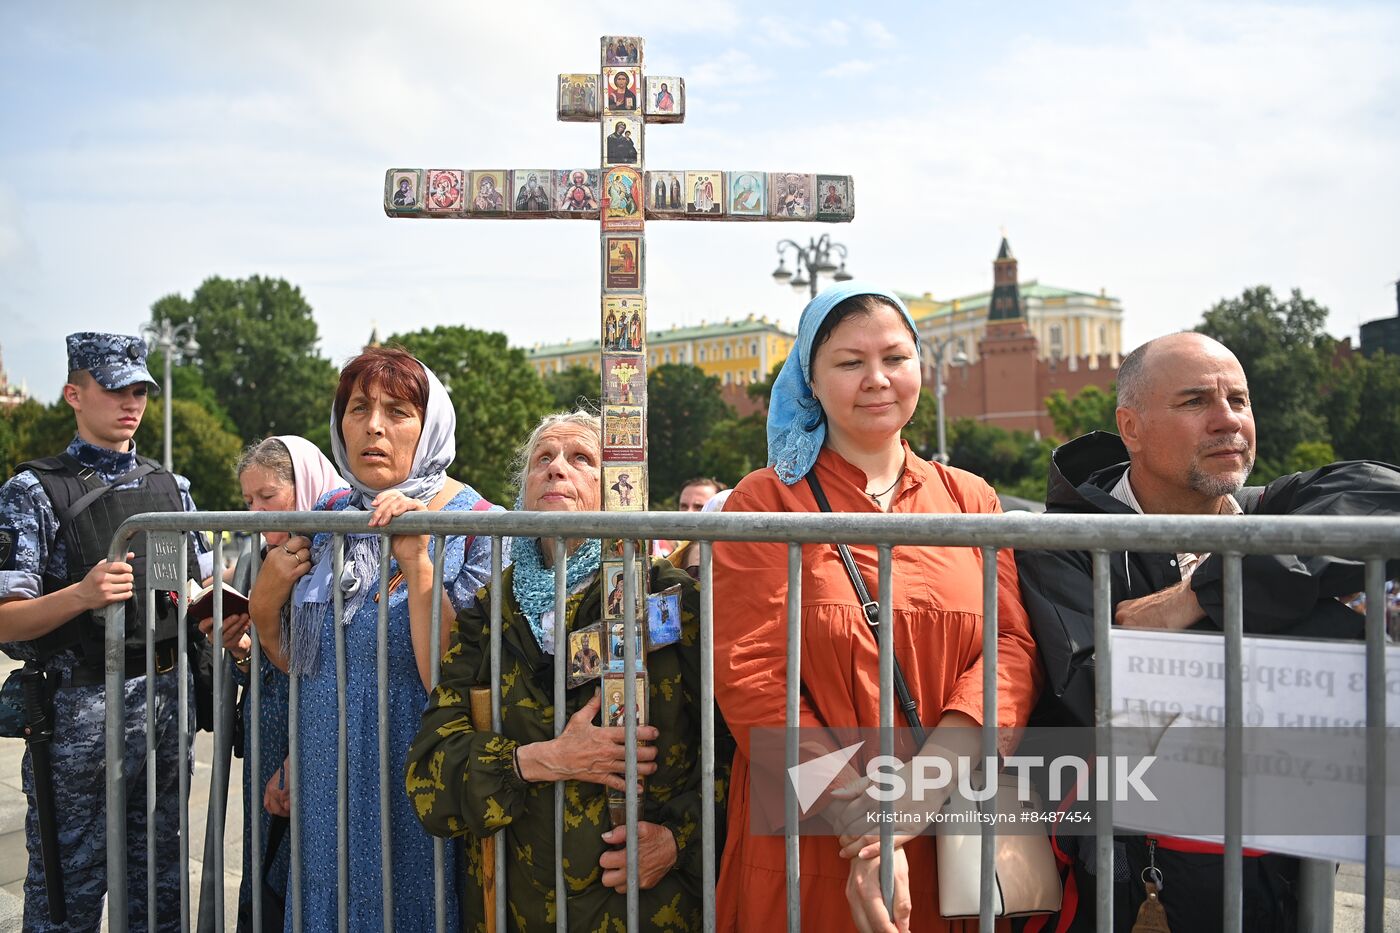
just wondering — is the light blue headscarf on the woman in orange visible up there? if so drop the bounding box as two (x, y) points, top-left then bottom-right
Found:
(769, 282), (918, 486)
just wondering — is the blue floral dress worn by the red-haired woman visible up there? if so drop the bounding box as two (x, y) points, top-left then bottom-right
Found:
(287, 486), (498, 933)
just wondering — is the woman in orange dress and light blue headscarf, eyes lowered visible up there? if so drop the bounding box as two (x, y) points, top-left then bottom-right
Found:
(714, 283), (1040, 933)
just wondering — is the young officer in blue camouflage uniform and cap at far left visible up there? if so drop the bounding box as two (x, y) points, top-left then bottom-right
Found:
(0, 332), (226, 930)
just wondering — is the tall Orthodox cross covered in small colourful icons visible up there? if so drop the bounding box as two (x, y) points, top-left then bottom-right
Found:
(384, 29), (855, 822)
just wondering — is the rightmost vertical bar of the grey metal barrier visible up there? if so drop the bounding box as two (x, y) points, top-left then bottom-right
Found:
(1364, 558), (1389, 933)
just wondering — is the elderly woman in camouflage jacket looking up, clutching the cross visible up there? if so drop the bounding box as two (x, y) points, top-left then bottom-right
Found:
(406, 412), (728, 932)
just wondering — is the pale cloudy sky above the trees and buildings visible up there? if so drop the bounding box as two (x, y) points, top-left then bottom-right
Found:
(0, 0), (1400, 401)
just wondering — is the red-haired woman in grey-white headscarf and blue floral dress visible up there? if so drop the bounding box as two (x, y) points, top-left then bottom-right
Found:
(252, 347), (494, 930)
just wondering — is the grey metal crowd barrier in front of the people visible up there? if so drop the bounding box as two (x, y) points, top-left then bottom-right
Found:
(104, 511), (1400, 933)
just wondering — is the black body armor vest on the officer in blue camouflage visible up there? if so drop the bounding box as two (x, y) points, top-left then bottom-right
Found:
(20, 454), (199, 665)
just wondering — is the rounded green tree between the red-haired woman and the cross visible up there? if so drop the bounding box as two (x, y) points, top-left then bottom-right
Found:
(392, 326), (553, 506)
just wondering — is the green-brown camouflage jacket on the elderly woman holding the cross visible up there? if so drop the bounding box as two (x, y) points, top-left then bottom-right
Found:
(406, 560), (732, 932)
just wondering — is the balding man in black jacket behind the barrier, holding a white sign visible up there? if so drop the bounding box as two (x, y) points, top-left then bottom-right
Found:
(1016, 333), (1400, 930)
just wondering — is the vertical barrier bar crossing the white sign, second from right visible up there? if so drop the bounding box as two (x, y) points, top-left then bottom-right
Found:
(1221, 552), (1245, 933)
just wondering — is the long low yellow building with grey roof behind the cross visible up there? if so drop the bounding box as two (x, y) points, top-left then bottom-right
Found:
(525, 314), (795, 385)
